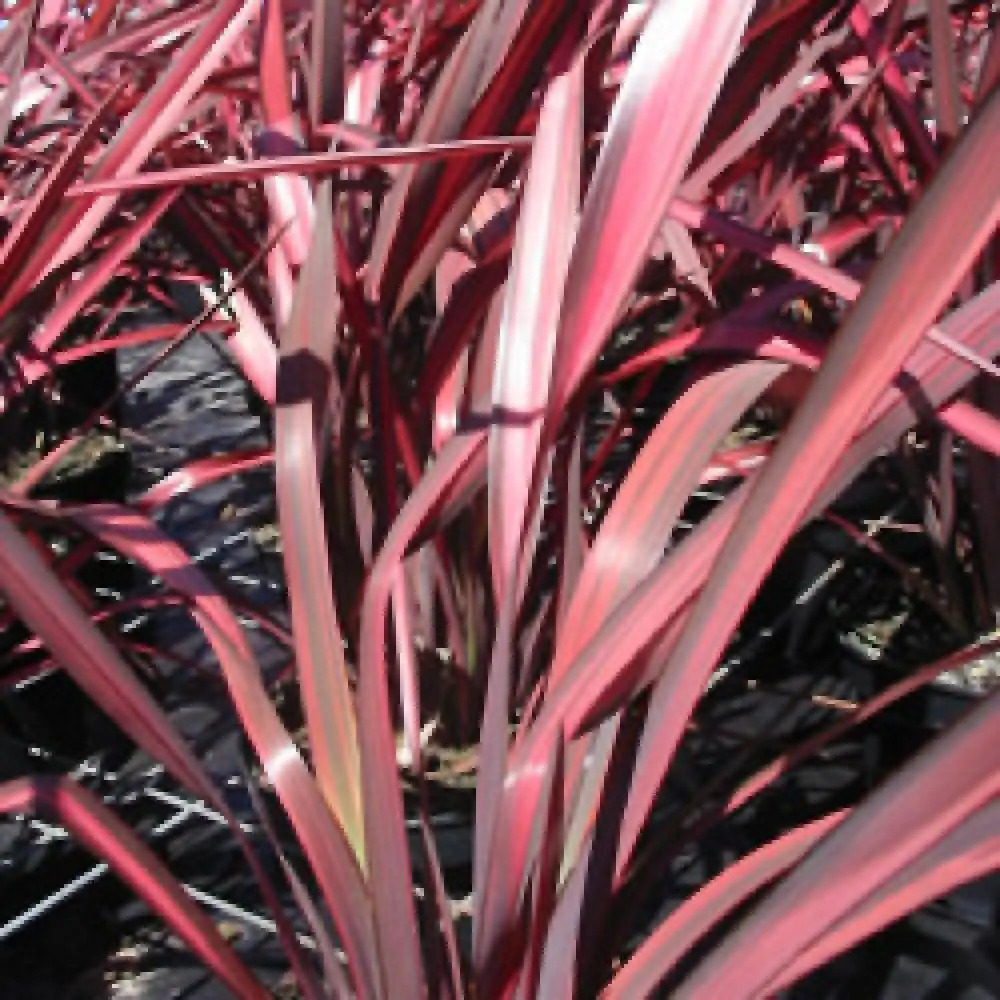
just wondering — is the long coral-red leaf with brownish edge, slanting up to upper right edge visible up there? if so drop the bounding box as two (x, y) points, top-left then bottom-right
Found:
(619, 88), (1000, 884)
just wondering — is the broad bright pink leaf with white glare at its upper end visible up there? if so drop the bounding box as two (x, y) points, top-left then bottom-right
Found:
(550, 0), (754, 420)
